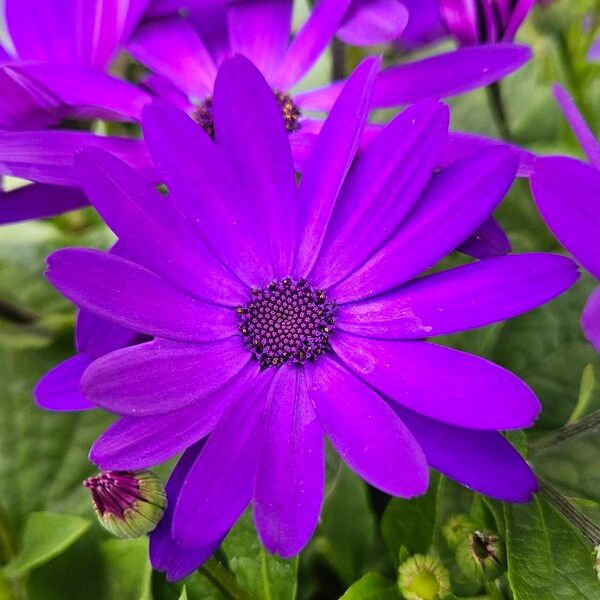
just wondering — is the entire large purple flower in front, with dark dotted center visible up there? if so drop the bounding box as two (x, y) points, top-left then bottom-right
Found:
(48, 56), (578, 579)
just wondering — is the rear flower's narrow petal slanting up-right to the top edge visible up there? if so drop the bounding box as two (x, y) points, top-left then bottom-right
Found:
(272, 0), (351, 90)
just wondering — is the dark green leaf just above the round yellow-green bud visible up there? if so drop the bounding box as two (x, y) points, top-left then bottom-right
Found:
(381, 472), (439, 566)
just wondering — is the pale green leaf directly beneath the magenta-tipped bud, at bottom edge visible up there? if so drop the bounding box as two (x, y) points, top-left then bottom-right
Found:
(100, 538), (152, 600)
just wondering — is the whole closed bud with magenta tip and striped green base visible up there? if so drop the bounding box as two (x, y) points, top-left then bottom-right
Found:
(83, 471), (167, 538)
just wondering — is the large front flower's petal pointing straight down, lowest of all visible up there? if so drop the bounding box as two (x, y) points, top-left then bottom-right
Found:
(254, 366), (325, 558)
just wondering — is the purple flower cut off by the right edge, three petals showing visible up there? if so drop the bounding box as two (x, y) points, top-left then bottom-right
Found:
(531, 84), (600, 352)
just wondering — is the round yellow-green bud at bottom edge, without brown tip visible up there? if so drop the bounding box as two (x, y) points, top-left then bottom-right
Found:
(398, 554), (450, 600)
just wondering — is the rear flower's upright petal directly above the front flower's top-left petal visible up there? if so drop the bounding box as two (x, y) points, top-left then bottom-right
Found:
(227, 0), (293, 79)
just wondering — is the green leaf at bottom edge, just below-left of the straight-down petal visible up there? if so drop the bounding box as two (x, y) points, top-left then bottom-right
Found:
(221, 510), (298, 600)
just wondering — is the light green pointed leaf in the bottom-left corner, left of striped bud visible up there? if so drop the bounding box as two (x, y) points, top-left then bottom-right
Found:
(4, 512), (90, 578)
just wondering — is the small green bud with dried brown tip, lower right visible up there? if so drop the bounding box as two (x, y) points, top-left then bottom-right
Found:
(456, 531), (506, 581)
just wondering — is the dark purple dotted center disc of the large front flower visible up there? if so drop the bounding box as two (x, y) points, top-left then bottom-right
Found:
(236, 278), (335, 369)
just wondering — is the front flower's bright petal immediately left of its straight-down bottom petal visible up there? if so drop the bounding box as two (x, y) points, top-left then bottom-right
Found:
(172, 370), (273, 548)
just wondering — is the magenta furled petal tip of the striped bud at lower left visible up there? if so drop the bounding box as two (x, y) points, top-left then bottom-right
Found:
(83, 471), (143, 517)
